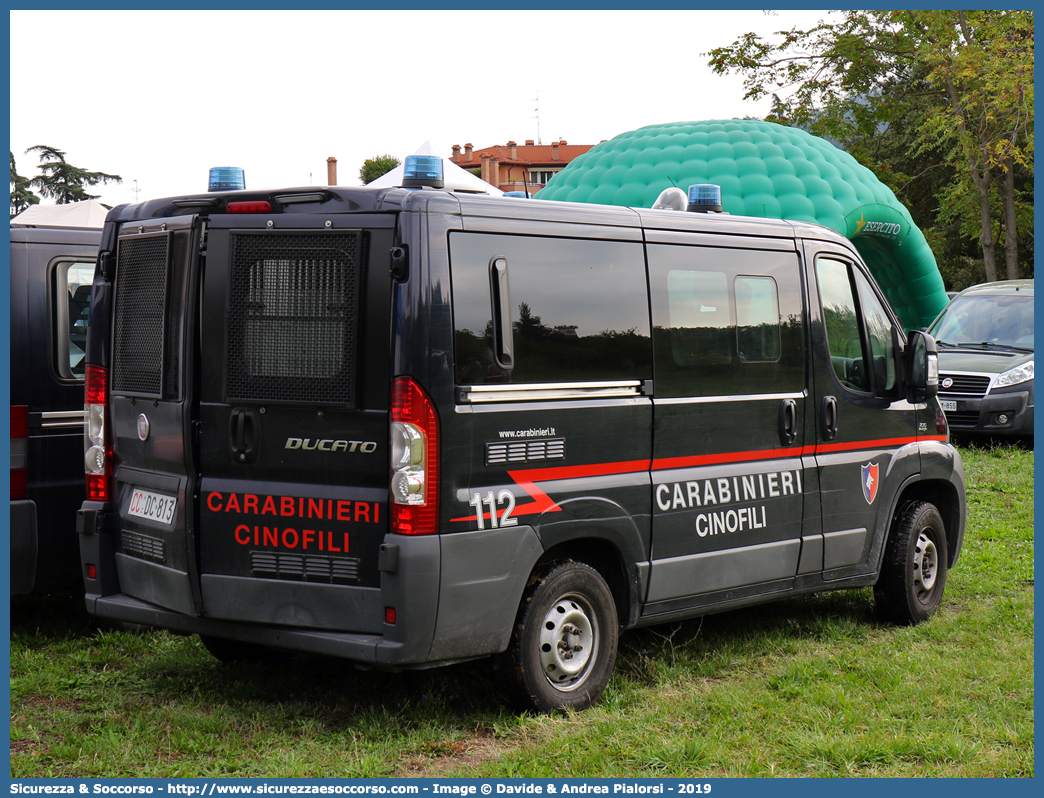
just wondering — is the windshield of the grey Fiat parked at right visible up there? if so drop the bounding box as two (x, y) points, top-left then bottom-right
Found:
(928, 296), (1034, 349)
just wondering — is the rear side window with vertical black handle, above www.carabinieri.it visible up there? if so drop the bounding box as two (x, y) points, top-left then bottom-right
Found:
(450, 233), (653, 385)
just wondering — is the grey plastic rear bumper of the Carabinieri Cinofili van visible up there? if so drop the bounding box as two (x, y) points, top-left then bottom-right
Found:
(77, 501), (542, 668)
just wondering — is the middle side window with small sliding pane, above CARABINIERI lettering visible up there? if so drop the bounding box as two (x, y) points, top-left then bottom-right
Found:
(648, 244), (805, 397)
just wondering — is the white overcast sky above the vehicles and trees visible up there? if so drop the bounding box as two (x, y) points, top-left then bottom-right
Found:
(10, 9), (825, 205)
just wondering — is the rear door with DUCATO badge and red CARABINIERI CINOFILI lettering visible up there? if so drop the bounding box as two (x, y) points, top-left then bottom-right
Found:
(195, 213), (396, 632)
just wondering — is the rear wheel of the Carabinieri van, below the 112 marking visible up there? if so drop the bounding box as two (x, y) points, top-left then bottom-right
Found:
(494, 560), (620, 713)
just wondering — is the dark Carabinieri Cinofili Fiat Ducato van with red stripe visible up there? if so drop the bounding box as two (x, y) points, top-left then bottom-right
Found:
(77, 165), (966, 711)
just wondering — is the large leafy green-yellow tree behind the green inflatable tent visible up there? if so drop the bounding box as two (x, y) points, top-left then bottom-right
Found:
(708, 9), (1034, 280)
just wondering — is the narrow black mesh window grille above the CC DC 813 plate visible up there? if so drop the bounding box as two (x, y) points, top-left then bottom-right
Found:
(113, 234), (169, 397)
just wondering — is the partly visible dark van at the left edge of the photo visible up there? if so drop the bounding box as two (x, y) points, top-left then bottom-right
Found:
(10, 222), (101, 593)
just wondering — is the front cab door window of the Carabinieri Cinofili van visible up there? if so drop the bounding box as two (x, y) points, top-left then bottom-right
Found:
(815, 258), (896, 394)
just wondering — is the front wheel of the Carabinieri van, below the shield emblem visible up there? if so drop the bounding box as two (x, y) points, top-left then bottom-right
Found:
(874, 501), (949, 626)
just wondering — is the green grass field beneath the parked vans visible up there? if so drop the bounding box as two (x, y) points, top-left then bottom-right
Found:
(10, 448), (1034, 777)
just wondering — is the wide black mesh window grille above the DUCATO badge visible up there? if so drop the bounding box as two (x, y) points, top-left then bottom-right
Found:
(226, 232), (363, 407)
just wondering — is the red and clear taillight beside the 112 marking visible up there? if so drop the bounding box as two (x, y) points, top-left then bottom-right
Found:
(390, 377), (438, 535)
